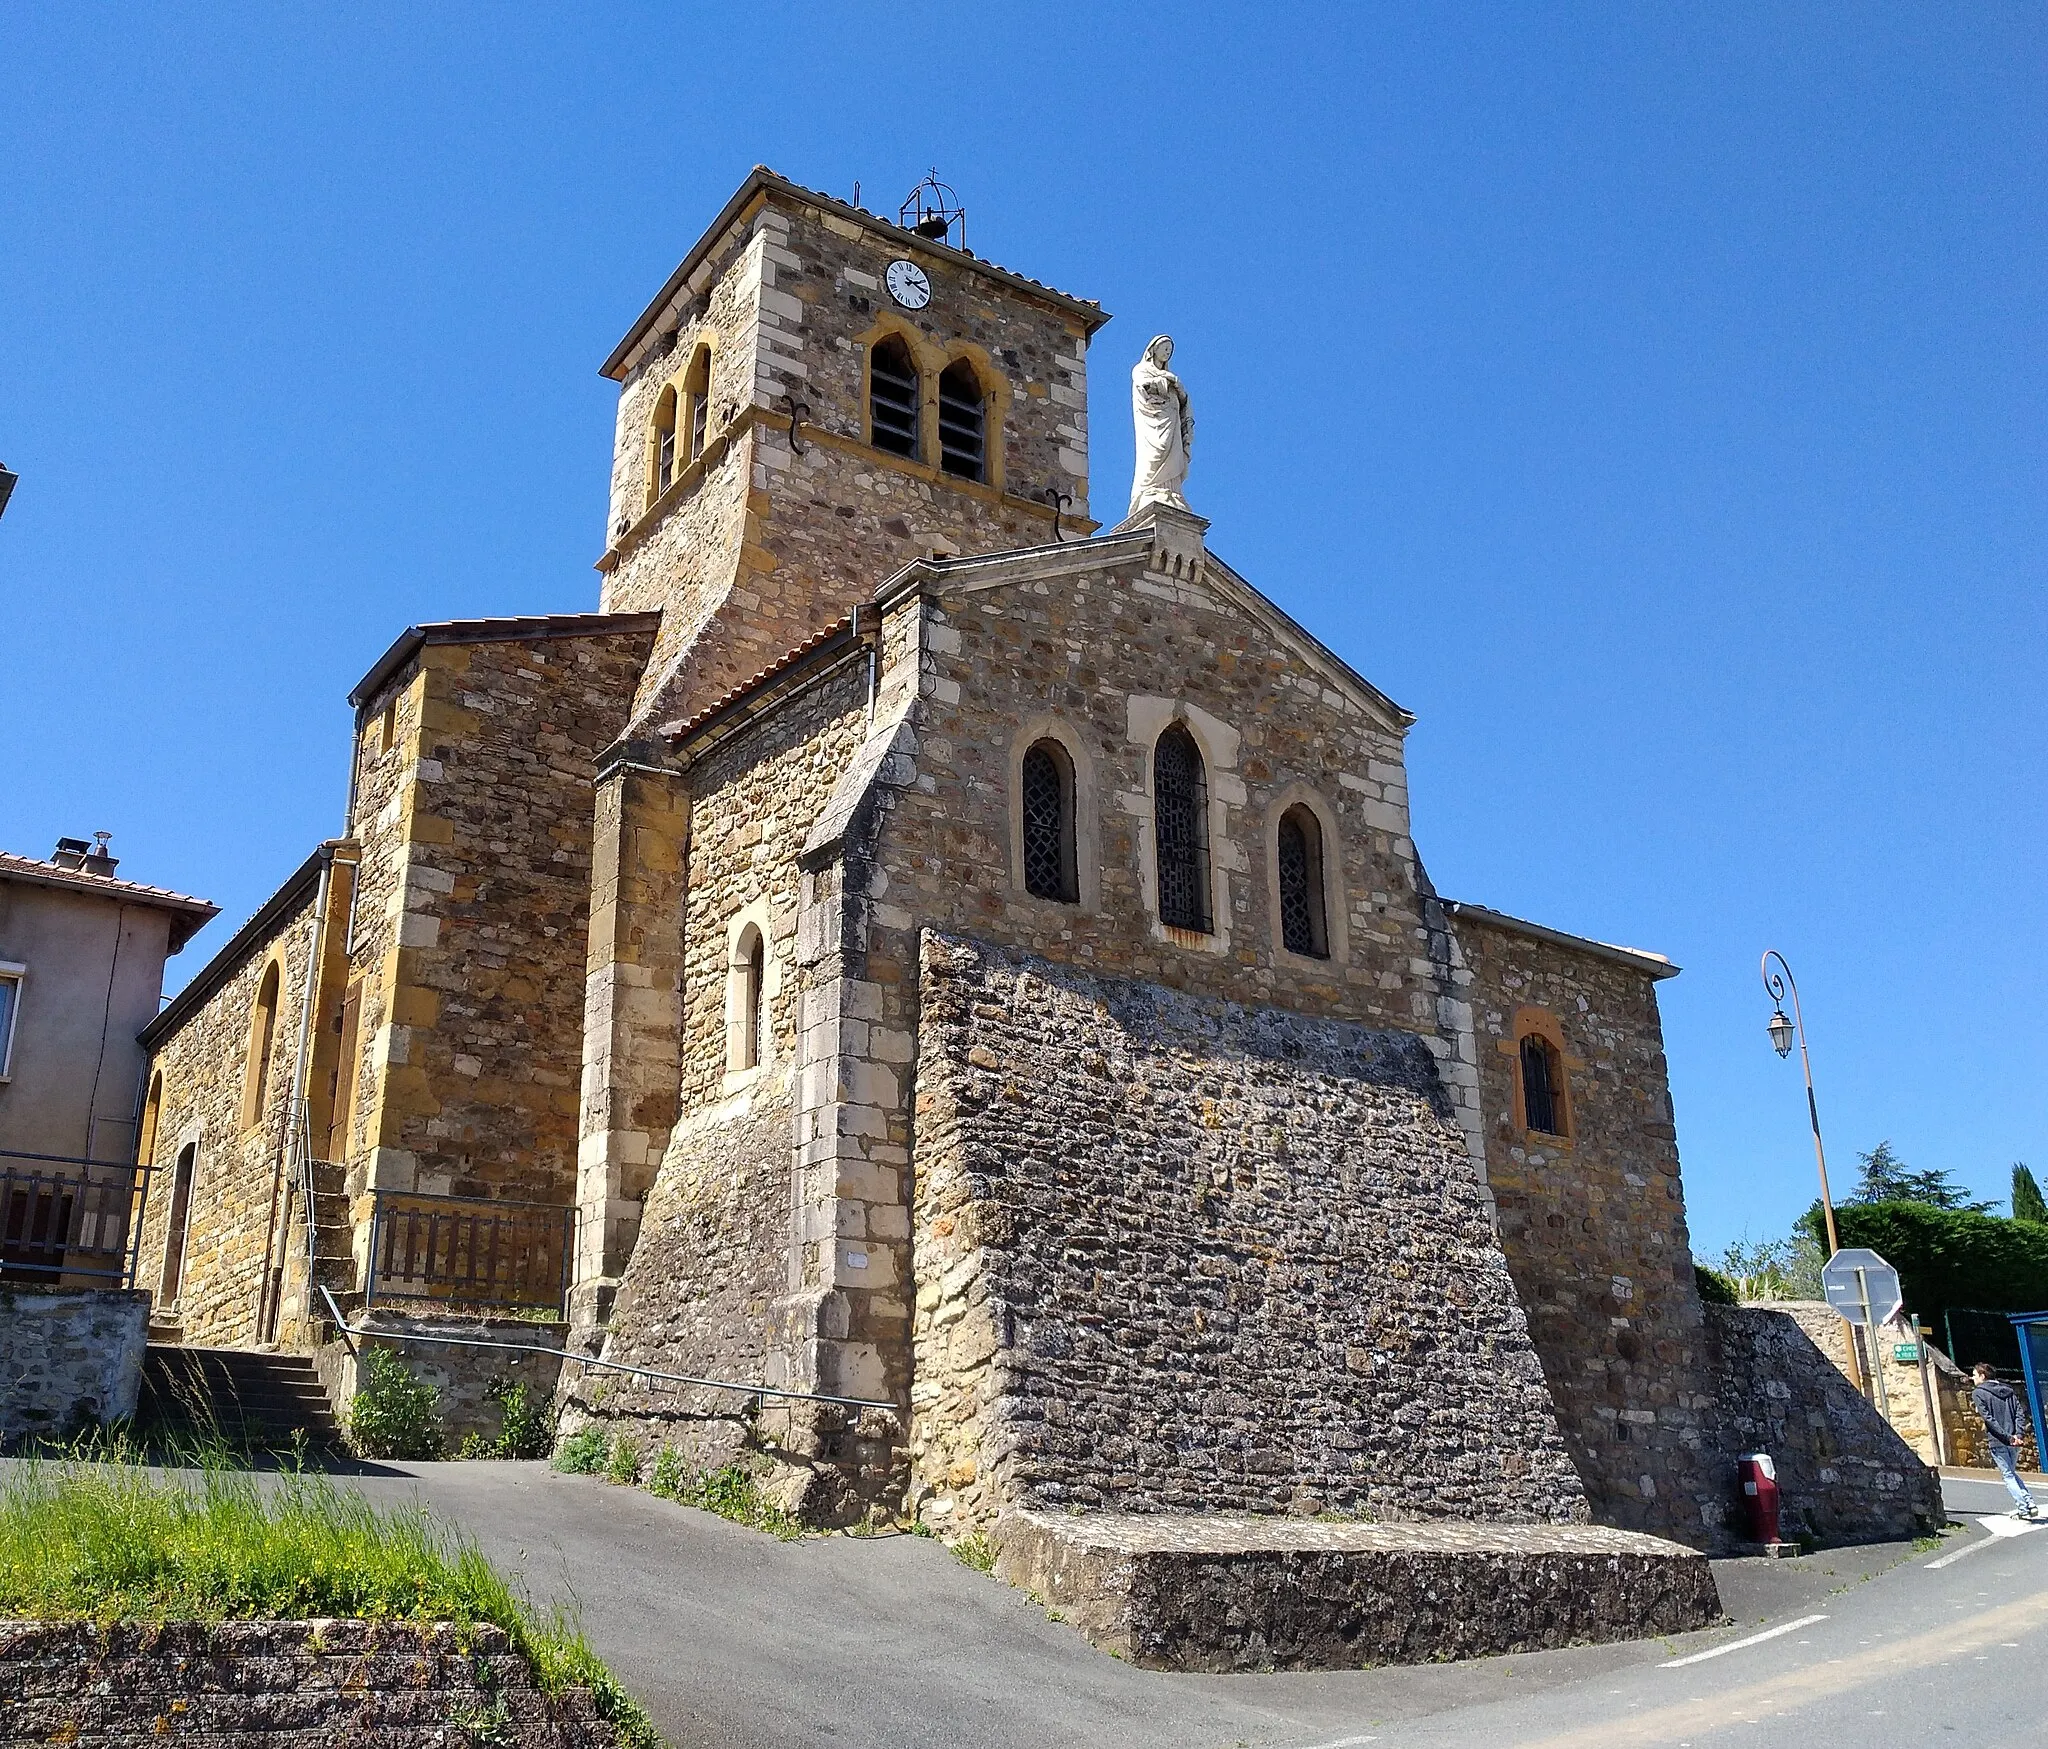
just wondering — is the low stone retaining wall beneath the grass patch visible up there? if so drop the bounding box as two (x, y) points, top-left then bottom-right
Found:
(0, 1622), (618, 1749)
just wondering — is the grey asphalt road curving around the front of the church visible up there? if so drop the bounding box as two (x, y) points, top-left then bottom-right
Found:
(350, 1464), (2048, 1749)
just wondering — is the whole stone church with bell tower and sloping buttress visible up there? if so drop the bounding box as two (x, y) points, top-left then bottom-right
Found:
(132, 170), (1933, 1546)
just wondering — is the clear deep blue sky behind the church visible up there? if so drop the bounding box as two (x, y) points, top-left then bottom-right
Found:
(0, 0), (2048, 1253)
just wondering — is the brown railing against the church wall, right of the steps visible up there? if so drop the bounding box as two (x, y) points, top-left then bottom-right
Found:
(362, 1190), (575, 1313)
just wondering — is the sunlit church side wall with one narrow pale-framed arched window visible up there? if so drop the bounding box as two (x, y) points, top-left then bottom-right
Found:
(565, 659), (876, 1473)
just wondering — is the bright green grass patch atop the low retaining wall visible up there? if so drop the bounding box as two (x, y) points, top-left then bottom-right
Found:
(0, 1458), (662, 1749)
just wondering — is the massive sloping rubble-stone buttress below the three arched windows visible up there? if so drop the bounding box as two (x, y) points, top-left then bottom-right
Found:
(911, 934), (1585, 1530)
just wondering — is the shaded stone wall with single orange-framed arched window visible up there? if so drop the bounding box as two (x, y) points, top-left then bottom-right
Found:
(1458, 913), (1733, 1546)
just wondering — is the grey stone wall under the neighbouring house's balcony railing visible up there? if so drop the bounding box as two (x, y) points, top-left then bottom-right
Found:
(0, 1282), (150, 1452)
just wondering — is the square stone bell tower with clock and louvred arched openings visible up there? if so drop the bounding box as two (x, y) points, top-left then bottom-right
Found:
(598, 168), (1108, 735)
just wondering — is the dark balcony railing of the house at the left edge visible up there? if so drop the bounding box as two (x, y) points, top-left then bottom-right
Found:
(0, 1149), (150, 1288)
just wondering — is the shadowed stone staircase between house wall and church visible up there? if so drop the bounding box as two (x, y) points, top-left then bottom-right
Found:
(137, 1343), (342, 1456)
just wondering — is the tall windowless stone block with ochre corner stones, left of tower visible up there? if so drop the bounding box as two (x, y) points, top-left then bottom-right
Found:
(339, 618), (653, 1229)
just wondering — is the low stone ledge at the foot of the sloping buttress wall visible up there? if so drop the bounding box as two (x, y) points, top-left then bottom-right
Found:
(995, 1511), (1720, 1671)
